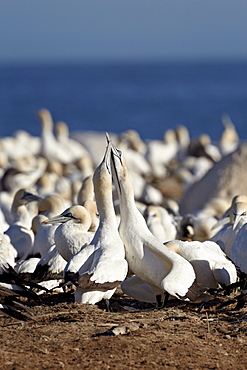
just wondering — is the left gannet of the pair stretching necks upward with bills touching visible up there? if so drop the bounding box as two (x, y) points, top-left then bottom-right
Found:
(68, 137), (128, 304)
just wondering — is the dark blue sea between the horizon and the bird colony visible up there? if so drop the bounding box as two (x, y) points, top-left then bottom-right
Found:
(0, 62), (247, 140)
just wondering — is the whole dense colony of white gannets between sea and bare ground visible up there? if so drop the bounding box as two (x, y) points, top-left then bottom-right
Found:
(0, 109), (247, 318)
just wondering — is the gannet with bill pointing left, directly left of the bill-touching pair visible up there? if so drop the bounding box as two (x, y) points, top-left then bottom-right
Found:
(43, 205), (94, 261)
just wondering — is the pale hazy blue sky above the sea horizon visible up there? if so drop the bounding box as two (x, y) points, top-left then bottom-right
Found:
(0, 0), (247, 62)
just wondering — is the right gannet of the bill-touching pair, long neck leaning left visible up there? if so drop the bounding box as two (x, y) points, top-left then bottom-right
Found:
(111, 137), (198, 306)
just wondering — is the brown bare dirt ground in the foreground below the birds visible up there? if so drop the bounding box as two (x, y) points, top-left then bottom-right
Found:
(0, 292), (247, 370)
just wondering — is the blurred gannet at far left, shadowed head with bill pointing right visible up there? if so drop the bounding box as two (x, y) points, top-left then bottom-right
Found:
(5, 189), (41, 259)
